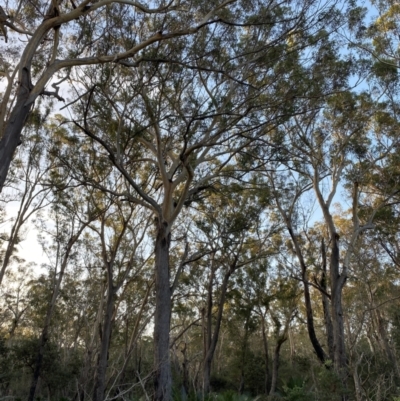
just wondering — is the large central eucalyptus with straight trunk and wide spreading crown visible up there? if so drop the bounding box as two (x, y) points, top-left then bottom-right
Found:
(43, 2), (354, 400)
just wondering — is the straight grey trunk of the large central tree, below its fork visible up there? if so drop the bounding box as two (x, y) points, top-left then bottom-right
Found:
(154, 222), (172, 401)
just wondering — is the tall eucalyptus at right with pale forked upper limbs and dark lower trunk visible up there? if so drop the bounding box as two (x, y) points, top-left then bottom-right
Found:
(260, 91), (395, 398)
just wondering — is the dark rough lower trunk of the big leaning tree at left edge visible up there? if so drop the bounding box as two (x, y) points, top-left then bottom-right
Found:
(0, 69), (32, 192)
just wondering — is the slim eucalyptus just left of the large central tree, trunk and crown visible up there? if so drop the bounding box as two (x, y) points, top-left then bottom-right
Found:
(90, 193), (151, 401)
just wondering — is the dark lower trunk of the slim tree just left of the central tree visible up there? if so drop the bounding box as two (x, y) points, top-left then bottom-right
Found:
(93, 276), (115, 401)
